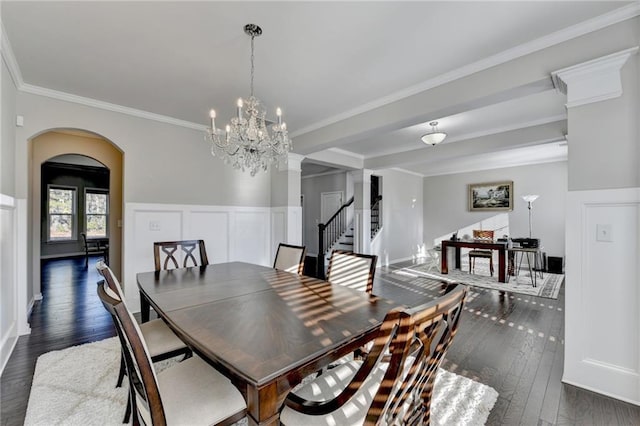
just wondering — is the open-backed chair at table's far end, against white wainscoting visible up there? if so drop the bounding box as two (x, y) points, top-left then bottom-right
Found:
(153, 240), (209, 271)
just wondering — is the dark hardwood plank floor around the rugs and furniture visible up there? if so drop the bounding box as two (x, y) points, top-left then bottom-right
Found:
(0, 258), (640, 425)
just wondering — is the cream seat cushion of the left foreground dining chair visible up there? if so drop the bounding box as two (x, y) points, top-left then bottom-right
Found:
(138, 356), (247, 426)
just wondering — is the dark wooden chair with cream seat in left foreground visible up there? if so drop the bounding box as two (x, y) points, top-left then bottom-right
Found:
(98, 280), (247, 426)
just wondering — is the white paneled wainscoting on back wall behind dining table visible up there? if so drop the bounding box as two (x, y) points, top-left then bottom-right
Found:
(123, 203), (288, 311)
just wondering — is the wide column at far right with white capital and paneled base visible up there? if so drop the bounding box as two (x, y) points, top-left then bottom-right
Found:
(552, 47), (640, 404)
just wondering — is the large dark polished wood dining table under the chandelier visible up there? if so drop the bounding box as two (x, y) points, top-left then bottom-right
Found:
(137, 262), (398, 425)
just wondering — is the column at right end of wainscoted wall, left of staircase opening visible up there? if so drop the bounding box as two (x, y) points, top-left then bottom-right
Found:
(271, 153), (304, 258)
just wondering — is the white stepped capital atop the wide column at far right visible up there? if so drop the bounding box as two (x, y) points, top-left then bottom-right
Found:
(551, 46), (638, 108)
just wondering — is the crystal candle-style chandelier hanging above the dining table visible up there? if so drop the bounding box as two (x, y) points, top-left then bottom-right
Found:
(205, 24), (293, 176)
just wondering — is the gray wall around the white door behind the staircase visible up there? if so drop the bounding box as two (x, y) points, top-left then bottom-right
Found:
(301, 172), (344, 254)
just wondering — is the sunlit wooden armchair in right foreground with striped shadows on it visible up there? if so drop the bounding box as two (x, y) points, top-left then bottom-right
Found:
(280, 284), (467, 426)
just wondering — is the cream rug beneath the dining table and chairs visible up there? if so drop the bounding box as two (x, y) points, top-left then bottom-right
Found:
(24, 337), (498, 426)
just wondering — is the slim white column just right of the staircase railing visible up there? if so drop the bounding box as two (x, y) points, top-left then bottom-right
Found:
(351, 169), (372, 254)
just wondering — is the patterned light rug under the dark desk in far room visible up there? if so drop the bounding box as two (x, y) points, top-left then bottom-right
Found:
(400, 264), (564, 299)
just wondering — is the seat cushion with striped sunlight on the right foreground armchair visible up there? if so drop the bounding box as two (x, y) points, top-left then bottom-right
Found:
(280, 361), (388, 426)
